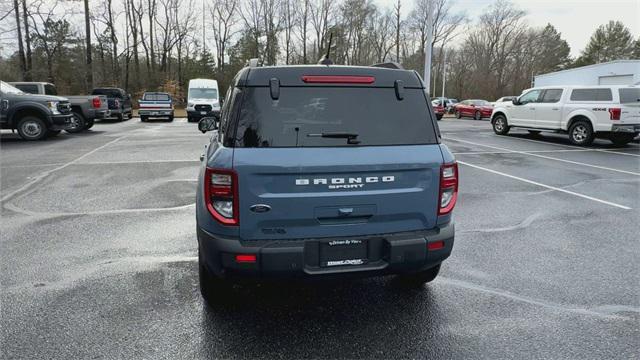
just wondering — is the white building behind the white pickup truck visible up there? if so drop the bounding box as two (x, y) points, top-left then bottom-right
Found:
(534, 60), (640, 86)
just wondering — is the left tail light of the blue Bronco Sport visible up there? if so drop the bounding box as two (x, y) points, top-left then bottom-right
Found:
(204, 168), (239, 226)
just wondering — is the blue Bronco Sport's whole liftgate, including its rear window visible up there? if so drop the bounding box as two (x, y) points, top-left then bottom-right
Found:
(233, 86), (442, 240)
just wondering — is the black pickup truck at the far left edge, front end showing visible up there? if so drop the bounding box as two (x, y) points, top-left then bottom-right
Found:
(0, 81), (73, 140)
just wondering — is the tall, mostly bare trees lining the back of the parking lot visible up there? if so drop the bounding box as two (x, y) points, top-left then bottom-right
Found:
(0, 0), (640, 100)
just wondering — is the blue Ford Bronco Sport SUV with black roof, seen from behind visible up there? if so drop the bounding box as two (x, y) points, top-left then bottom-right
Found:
(196, 65), (458, 302)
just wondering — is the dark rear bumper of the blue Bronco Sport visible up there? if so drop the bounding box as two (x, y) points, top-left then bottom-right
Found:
(198, 222), (455, 278)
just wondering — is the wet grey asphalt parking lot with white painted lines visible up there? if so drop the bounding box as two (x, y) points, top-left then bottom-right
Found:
(0, 119), (640, 359)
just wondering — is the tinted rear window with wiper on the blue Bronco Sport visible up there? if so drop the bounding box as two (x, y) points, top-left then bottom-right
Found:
(235, 87), (437, 147)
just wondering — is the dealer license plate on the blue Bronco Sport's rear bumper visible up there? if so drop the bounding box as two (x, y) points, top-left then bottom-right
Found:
(319, 240), (368, 267)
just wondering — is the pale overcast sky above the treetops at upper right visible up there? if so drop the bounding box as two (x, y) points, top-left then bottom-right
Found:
(375, 0), (640, 56)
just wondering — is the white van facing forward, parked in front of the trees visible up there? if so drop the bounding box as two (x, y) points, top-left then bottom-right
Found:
(187, 79), (220, 122)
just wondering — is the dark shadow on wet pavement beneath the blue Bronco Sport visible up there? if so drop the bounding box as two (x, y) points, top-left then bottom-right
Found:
(202, 279), (447, 358)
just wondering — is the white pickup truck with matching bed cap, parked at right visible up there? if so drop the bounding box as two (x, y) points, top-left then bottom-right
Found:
(491, 85), (640, 146)
